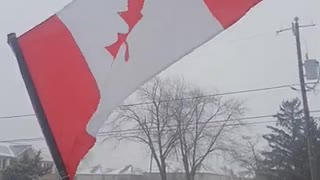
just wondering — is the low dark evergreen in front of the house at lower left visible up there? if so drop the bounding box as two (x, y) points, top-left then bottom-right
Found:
(3, 151), (52, 180)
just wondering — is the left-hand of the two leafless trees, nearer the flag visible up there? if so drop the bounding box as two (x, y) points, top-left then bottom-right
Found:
(112, 79), (179, 180)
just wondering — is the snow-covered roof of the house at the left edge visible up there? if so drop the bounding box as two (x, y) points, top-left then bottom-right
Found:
(0, 143), (31, 158)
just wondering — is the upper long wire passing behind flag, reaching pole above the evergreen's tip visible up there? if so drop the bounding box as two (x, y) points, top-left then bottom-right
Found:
(0, 83), (312, 120)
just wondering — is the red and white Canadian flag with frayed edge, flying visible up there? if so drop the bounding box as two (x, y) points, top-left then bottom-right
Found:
(9, 0), (260, 179)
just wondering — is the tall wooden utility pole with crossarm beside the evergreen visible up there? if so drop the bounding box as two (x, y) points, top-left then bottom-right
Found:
(277, 17), (320, 180)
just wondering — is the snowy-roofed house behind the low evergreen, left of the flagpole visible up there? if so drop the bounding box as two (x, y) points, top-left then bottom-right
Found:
(0, 143), (55, 180)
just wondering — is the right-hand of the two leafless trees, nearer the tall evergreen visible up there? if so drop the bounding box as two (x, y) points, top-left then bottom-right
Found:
(174, 84), (242, 180)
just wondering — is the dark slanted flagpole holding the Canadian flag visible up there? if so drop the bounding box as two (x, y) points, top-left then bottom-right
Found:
(8, 33), (70, 180)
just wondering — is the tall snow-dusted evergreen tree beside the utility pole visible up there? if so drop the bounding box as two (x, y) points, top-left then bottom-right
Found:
(263, 98), (320, 180)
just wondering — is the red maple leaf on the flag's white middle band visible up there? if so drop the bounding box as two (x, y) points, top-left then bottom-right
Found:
(106, 0), (144, 62)
